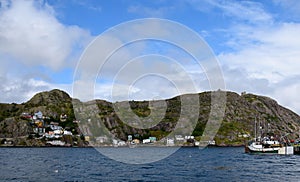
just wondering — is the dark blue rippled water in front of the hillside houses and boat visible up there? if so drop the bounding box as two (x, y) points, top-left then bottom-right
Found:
(0, 147), (300, 181)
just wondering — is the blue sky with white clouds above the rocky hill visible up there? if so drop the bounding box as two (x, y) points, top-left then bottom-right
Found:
(0, 0), (300, 114)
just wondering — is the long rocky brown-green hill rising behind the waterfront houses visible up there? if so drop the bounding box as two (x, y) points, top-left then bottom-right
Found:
(0, 90), (300, 145)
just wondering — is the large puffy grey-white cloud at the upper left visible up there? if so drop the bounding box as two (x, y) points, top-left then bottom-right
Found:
(0, 1), (89, 70)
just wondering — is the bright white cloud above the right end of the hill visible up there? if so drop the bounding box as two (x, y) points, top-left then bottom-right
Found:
(219, 23), (300, 83)
